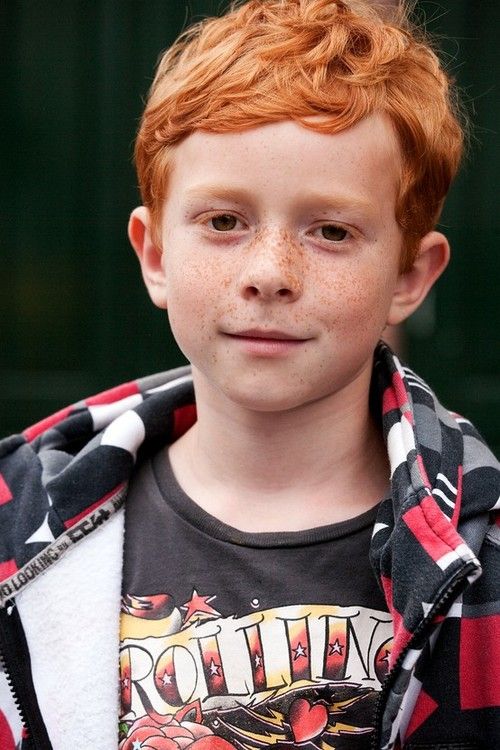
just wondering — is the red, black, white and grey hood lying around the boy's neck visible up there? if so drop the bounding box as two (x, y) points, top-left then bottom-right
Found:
(0, 343), (500, 657)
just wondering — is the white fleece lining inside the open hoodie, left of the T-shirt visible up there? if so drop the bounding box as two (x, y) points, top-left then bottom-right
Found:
(17, 510), (124, 750)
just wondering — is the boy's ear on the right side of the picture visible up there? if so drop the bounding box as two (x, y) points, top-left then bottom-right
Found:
(387, 231), (450, 325)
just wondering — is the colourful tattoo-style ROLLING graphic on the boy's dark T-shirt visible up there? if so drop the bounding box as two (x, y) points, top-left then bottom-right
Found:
(120, 590), (392, 750)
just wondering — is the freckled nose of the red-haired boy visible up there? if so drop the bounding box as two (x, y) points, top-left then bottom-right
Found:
(240, 232), (304, 302)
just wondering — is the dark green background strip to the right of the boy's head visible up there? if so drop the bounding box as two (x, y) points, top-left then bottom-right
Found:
(407, 0), (500, 455)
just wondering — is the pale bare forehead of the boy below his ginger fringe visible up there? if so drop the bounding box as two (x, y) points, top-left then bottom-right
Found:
(169, 115), (401, 213)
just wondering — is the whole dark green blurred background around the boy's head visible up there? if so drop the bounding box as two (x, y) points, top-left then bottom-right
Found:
(0, 0), (500, 451)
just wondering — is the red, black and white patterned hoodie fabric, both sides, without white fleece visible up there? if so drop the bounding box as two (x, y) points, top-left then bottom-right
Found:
(0, 344), (500, 749)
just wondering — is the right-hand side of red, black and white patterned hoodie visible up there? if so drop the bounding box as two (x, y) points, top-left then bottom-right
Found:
(371, 345), (500, 748)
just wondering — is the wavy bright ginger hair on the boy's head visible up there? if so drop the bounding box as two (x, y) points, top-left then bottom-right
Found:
(135, 0), (463, 271)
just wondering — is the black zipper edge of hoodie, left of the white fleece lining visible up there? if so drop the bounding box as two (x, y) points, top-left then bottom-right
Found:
(0, 604), (52, 750)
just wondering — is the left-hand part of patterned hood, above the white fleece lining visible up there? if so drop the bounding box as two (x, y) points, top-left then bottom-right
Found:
(0, 368), (195, 606)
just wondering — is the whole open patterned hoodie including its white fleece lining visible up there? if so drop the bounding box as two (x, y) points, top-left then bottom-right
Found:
(0, 344), (500, 750)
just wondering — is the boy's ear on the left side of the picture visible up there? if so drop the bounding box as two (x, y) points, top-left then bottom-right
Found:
(128, 206), (167, 310)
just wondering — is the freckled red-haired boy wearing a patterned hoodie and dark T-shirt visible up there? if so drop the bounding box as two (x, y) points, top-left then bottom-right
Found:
(0, 0), (500, 750)
